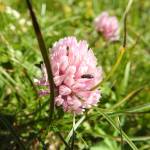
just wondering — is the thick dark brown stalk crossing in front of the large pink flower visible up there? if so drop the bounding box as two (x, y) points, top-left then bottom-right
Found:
(26, 0), (55, 121)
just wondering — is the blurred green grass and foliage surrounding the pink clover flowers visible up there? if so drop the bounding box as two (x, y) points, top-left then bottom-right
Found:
(0, 0), (150, 150)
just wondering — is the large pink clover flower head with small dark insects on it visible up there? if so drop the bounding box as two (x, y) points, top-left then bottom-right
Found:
(35, 37), (102, 114)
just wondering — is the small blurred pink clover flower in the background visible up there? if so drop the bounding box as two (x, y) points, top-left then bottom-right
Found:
(94, 12), (119, 41)
